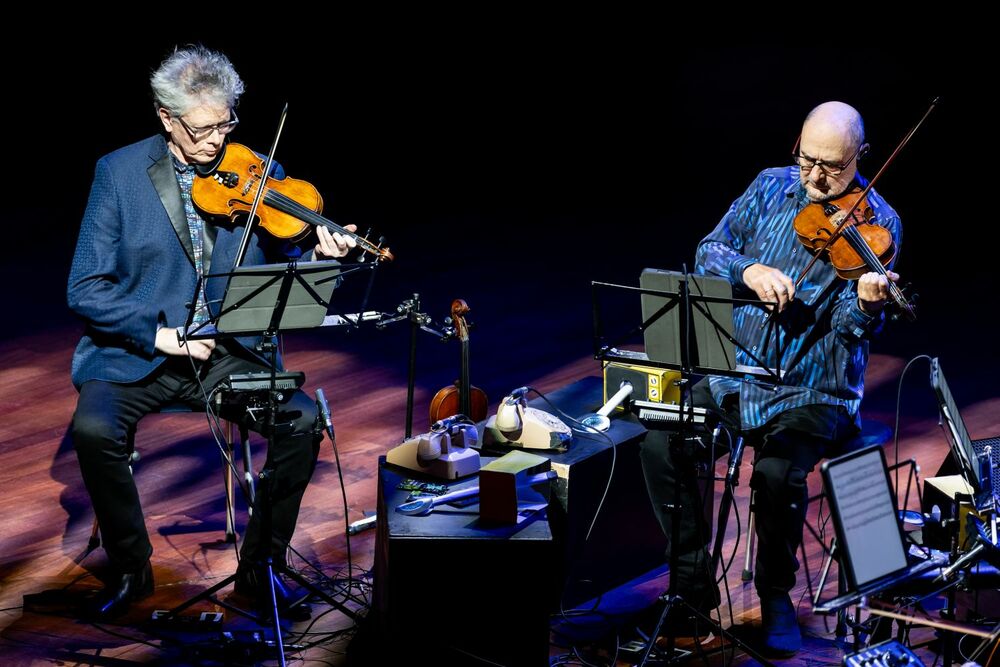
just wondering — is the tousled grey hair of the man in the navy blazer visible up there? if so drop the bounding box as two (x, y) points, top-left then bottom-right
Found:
(149, 45), (243, 116)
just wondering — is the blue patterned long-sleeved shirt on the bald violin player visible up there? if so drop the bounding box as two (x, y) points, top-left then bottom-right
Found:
(695, 166), (902, 429)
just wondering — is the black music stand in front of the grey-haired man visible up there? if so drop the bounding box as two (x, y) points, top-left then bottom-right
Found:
(165, 260), (367, 665)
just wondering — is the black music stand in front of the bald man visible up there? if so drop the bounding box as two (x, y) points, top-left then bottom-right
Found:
(592, 269), (783, 665)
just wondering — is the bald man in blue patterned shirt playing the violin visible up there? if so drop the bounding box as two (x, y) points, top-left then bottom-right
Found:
(642, 102), (901, 657)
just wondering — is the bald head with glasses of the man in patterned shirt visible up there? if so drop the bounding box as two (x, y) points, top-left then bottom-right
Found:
(799, 102), (865, 201)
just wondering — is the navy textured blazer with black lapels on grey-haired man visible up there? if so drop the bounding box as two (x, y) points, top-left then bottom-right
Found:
(67, 135), (292, 388)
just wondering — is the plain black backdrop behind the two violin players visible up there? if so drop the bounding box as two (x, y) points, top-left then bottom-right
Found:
(0, 30), (1000, 418)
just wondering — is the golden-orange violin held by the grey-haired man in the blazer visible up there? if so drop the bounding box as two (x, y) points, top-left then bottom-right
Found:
(191, 143), (394, 261)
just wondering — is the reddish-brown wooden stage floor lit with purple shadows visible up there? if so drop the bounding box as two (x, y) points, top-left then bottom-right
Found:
(0, 324), (1000, 665)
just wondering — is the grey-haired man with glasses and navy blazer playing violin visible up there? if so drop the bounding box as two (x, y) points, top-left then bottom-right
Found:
(68, 46), (355, 619)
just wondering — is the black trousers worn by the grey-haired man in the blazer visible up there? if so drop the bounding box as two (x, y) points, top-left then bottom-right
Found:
(72, 344), (322, 572)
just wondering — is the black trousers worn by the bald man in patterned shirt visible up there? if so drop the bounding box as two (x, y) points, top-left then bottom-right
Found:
(640, 378), (857, 603)
